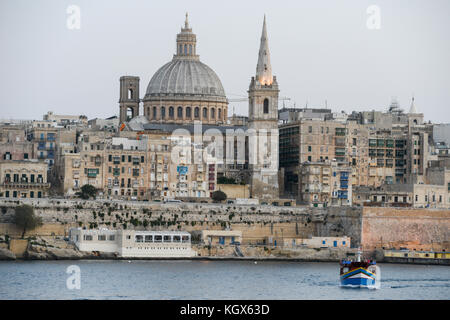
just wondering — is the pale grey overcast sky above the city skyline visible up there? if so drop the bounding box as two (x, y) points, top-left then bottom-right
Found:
(0, 0), (450, 123)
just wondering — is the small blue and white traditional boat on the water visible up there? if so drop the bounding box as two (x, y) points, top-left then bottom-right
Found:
(340, 250), (379, 288)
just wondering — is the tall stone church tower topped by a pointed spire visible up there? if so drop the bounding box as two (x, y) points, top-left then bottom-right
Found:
(248, 16), (280, 199)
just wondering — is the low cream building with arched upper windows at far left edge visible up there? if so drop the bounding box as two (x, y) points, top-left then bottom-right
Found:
(0, 160), (50, 199)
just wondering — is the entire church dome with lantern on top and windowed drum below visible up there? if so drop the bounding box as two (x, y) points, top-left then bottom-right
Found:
(142, 14), (228, 125)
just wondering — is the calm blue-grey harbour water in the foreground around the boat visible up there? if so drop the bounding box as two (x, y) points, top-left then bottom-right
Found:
(0, 261), (450, 299)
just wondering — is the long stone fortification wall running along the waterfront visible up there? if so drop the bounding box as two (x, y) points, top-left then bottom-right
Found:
(0, 199), (450, 250)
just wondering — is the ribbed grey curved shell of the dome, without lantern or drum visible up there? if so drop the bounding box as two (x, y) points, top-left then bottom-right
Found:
(144, 55), (226, 101)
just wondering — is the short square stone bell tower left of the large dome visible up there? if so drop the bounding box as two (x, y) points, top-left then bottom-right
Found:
(119, 76), (140, 123)
